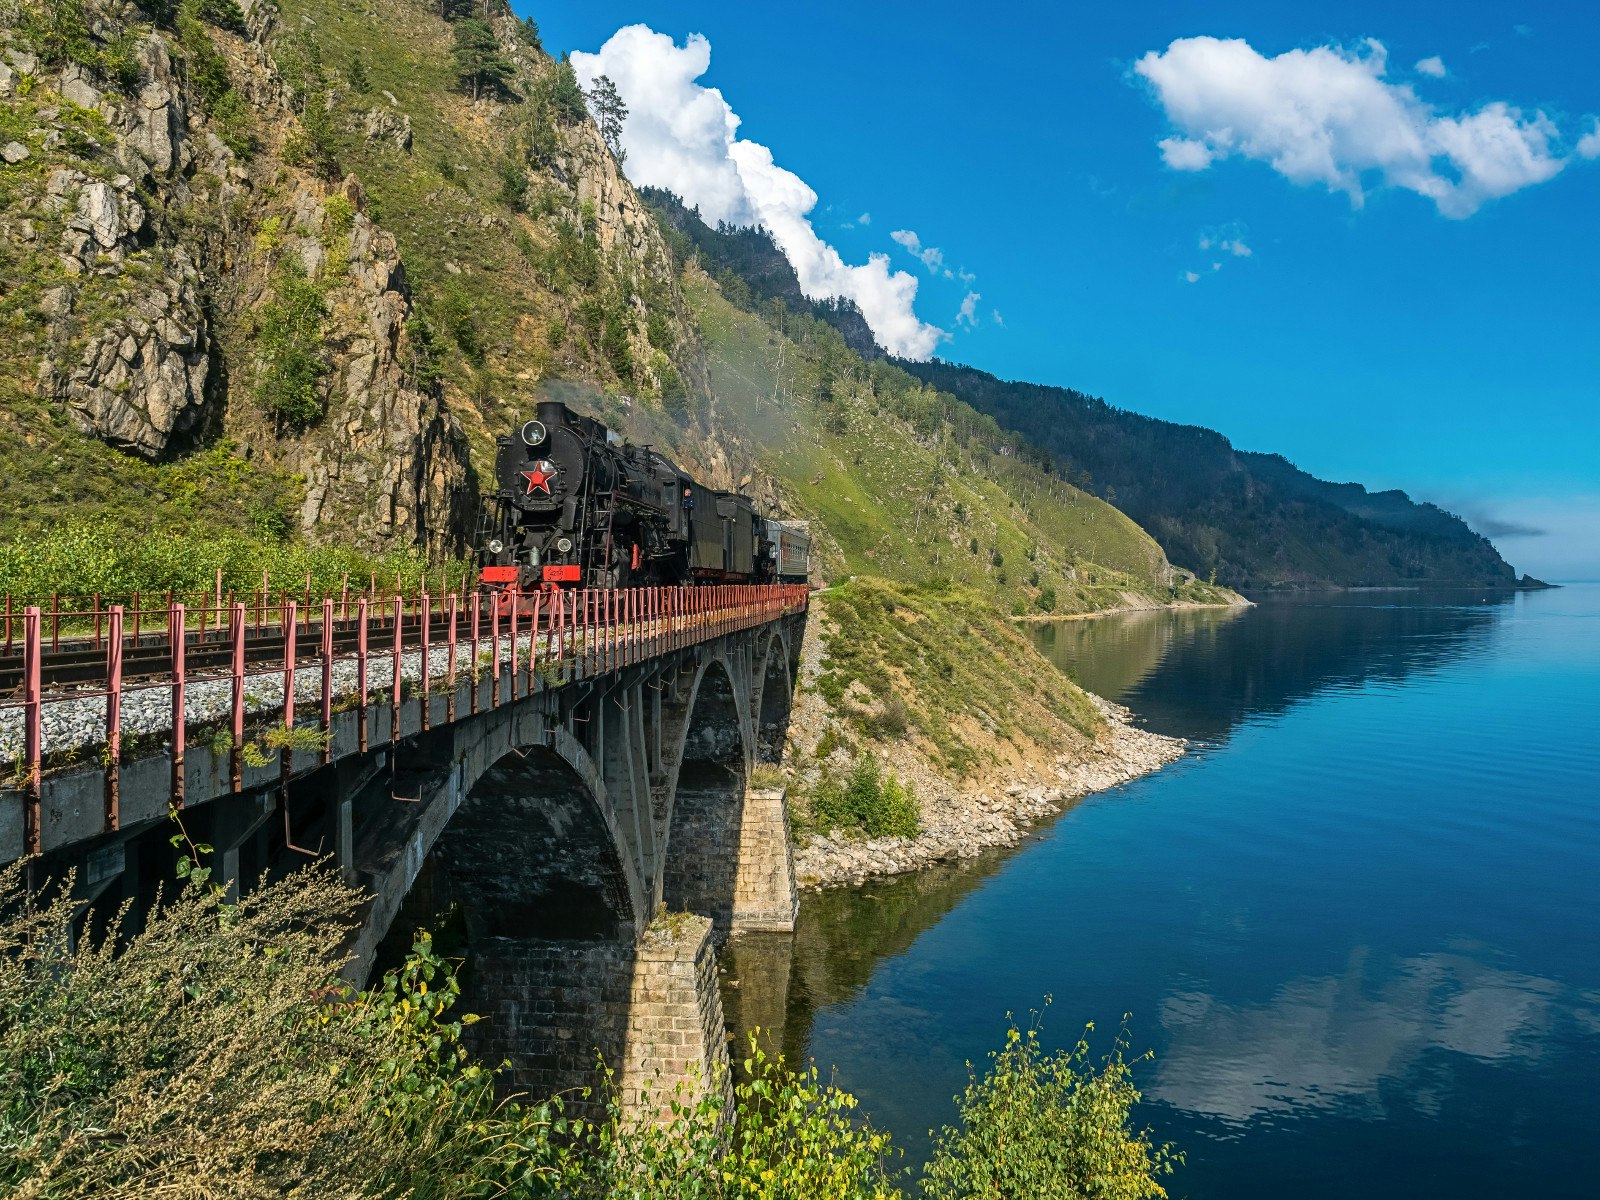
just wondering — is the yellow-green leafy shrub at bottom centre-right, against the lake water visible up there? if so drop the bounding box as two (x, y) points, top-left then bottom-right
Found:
(922, 1002), (1182, 1200)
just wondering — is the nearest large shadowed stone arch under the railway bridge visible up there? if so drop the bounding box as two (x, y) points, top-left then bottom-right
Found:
(366, 710), (651, 1096)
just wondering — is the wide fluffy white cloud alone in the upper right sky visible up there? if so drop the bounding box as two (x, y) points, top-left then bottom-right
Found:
(1133, 37), (1568, 218)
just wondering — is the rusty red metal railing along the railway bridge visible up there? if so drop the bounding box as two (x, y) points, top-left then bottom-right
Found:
(0, 584), (808, 853)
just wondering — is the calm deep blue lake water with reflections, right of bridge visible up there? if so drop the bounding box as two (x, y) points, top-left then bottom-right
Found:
(725, 586), (1600, 1200)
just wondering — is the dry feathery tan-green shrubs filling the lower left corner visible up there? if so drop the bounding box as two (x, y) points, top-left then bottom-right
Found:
(0, 848), (557, 1200)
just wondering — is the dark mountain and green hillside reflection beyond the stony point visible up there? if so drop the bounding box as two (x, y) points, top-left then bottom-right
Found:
(1034, 592), (1515, 741)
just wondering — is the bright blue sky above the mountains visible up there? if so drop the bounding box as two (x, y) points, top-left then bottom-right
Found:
(515, 0), (1600, 578)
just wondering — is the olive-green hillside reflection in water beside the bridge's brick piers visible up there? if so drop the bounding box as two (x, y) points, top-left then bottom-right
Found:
(722, 848), (1014, 1062)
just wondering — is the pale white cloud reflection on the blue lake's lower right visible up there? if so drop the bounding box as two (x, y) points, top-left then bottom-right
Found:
(1149, 946), (1562, 1123)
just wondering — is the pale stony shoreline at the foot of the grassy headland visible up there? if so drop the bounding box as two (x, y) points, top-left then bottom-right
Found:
(794, 696), (1187, 891)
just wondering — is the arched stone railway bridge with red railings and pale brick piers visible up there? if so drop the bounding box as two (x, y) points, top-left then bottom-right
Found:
(0, 586), (806, 1104)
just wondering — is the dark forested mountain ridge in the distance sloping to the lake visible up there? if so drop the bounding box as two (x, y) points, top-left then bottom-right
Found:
(627, 203), (1542, 590)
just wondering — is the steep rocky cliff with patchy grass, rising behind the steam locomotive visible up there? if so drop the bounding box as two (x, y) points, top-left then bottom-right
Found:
(0, 0), (706, 554)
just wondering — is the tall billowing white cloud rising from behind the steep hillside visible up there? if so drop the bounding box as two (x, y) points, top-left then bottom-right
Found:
(571, 26), (947, 358)
